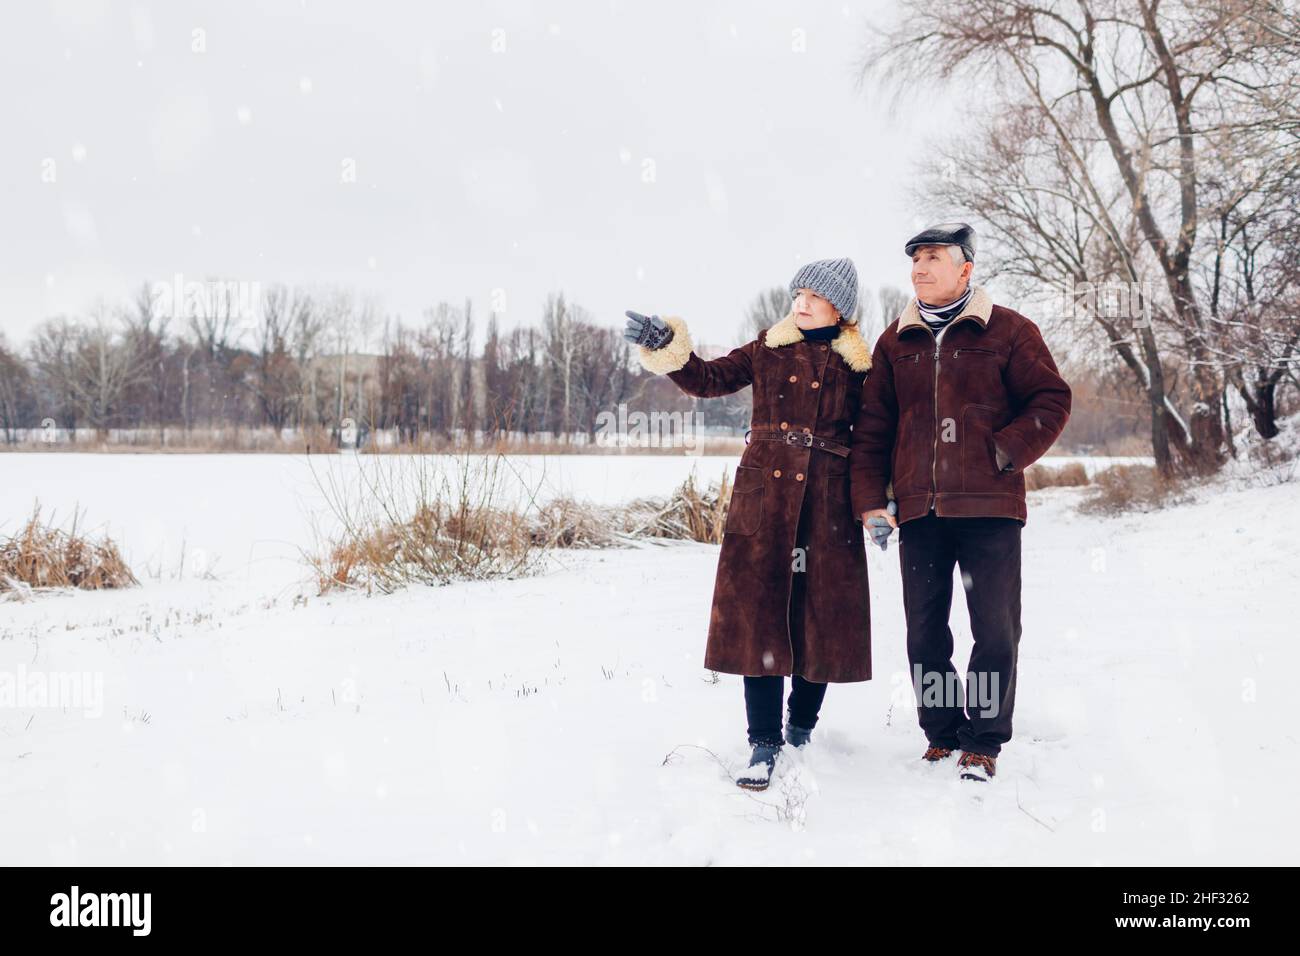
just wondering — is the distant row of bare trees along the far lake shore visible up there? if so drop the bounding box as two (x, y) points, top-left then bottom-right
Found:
(0, 282), (759, 444)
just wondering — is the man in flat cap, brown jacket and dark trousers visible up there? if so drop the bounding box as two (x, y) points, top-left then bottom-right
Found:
(850, 222), (1070, 782)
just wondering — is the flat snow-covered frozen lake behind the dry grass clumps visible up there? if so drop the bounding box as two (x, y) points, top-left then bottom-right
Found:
(0, 453), (1141, 580)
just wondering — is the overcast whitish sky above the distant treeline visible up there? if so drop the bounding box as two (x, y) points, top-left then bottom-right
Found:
(0, 0), (959, 345)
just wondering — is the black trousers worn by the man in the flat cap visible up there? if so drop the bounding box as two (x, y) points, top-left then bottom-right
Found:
(900, 512), (1022, 757)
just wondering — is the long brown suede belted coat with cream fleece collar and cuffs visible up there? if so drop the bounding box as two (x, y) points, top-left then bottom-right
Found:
(640, 315), (871, 683)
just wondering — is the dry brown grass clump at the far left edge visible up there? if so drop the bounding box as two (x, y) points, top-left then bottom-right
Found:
(0, 505), (139, 600)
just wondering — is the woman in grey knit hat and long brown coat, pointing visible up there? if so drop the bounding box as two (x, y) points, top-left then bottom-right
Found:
(624, 259), (871, 790)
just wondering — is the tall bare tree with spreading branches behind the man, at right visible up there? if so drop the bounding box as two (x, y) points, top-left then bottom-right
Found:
(872, 0), (1300, 471)
